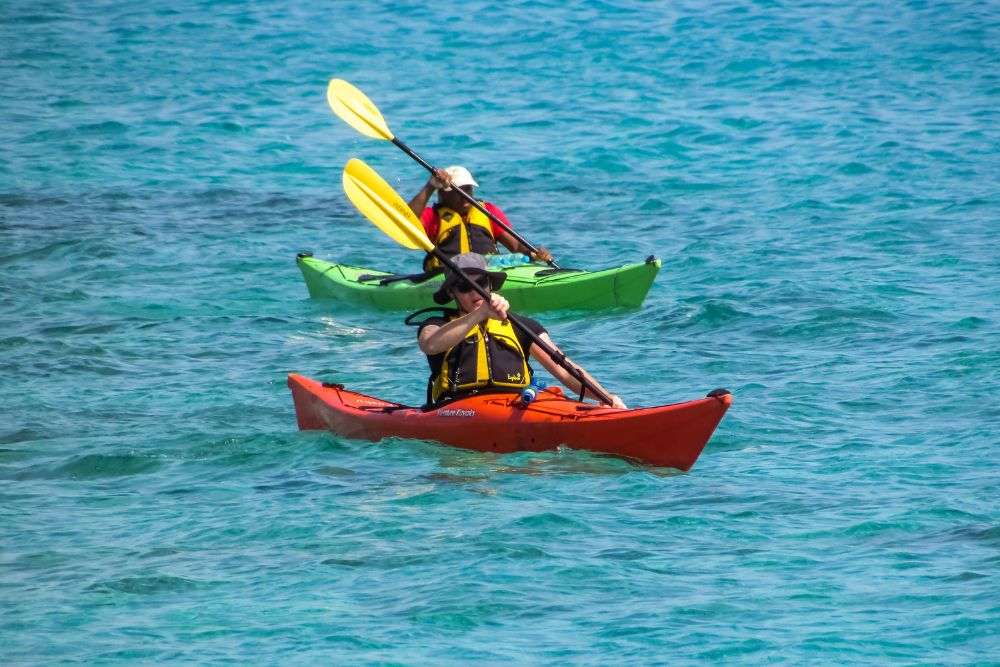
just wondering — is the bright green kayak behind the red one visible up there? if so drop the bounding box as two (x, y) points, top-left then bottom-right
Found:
(297, 253), (660, 313)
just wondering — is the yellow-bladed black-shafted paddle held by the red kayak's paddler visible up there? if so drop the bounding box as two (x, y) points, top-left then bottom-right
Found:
(343, 158), (612, 405)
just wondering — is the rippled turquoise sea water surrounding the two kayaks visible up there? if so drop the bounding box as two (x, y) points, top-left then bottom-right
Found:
(0, 0), (1000, 665)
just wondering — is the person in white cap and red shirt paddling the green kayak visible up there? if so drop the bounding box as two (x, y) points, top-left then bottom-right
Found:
(409, 166), (552, 271)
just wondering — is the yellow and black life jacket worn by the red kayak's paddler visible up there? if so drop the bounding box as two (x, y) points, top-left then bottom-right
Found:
(430, 314), (531, 402)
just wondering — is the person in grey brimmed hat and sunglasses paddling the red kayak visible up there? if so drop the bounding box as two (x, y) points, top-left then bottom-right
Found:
(411, 252), (625, 408)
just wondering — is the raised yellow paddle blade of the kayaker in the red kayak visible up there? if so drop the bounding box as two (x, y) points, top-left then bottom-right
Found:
(344, 158), (434, 252)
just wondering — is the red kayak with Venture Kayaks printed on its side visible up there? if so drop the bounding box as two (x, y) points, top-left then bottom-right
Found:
(288, 374), (733, 470)
